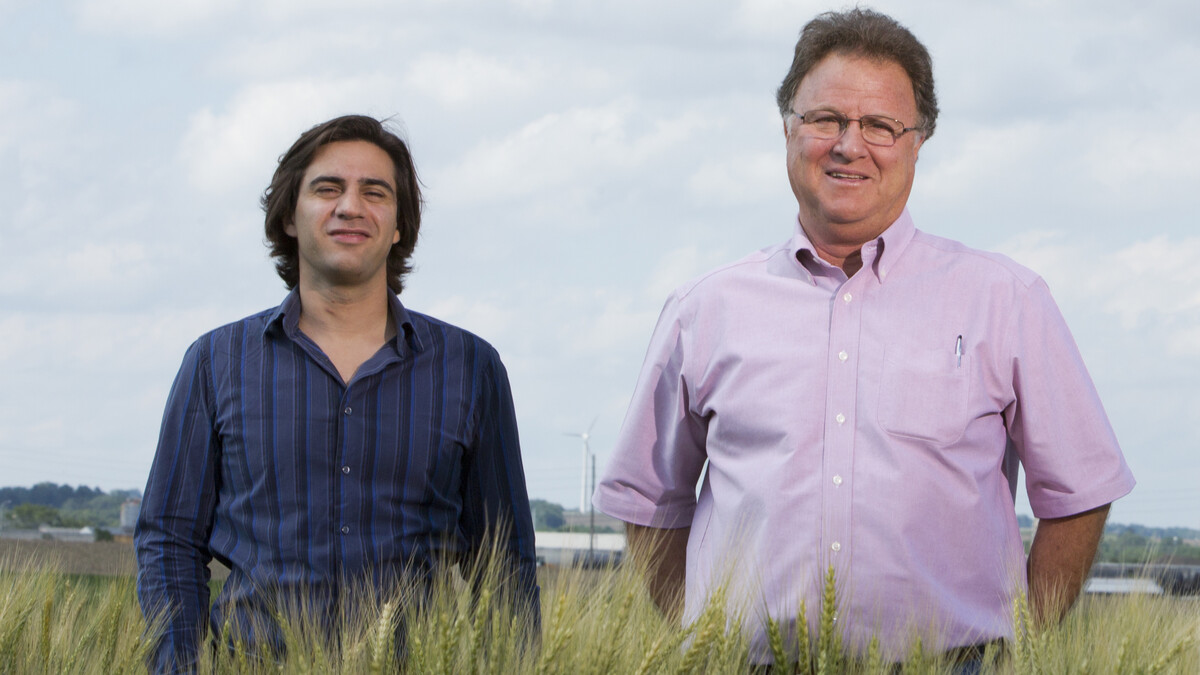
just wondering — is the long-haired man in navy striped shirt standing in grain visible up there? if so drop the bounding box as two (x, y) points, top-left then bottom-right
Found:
(136, 115), (538, 671)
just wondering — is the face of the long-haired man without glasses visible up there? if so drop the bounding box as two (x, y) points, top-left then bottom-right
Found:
(286, 141), (400, 288)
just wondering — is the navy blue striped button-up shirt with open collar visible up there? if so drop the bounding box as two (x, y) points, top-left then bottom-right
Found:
(134, 292), (538, 669)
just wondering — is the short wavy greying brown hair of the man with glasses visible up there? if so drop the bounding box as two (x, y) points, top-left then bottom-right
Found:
(775, 7), (937, 138)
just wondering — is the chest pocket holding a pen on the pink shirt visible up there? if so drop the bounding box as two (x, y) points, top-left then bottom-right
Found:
(877, 341), (971, 444)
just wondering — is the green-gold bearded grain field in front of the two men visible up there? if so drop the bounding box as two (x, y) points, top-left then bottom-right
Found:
(0, 544), (1200, 675)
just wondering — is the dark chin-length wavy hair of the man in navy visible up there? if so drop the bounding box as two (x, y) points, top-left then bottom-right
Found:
(260, 115), (422, 293)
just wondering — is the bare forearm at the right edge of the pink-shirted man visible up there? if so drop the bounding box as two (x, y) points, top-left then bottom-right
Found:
(1027, 504), (1109, 623)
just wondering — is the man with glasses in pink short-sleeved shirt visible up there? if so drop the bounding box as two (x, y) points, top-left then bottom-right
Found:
(595, 10), (1134, 664)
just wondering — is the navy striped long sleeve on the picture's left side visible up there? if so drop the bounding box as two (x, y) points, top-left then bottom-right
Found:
(134, 340), (220, 673)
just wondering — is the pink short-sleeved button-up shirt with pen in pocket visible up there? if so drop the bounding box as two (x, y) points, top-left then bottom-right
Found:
(594, 211), (1134, 658)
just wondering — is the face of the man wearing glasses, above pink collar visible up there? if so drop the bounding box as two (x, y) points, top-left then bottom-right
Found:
(784, 54), (923, 250)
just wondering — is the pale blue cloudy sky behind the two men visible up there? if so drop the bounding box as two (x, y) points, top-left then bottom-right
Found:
(0, 0), (1200, 527)
